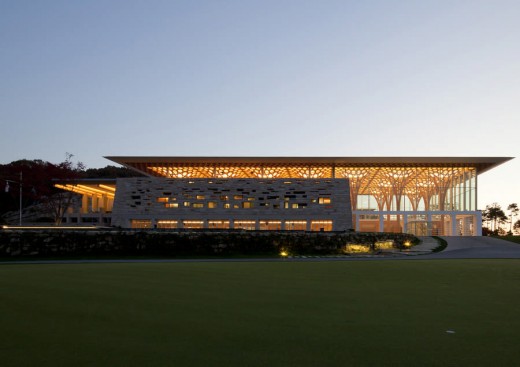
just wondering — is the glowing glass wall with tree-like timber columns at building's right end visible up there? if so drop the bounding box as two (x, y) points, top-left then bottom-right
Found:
(350, 167), (477, 235)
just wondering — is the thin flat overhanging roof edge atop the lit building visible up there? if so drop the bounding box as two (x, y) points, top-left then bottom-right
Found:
(104, 156), (513, 174)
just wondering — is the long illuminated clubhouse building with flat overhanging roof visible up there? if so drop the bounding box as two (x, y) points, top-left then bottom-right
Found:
(58, 157), (511, 236)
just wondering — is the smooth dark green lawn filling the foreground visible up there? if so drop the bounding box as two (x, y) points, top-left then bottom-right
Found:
(0, 260), (520, 366)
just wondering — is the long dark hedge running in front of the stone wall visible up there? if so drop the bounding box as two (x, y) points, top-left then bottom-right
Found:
(0, 230), (418, 258)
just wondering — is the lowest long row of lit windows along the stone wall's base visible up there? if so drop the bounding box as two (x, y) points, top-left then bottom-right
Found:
(131, 219), (333, 231)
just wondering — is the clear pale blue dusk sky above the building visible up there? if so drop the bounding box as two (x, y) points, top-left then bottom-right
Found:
(0, 0), (520, 208)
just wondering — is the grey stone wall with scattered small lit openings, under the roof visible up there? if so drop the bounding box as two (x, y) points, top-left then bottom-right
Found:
(112, 177), (352, 231)
